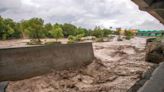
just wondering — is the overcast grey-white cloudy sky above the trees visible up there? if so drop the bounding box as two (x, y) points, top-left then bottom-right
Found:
(0, 0), (164, 29)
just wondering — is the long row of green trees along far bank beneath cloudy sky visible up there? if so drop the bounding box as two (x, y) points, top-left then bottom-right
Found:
(0, 16), (113, 40)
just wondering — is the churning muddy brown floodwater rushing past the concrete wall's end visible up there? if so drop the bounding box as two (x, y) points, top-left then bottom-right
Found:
(4, 37), (152, 92)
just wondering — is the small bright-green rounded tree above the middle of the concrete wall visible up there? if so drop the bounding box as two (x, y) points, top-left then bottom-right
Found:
(50, 25), (64, 42)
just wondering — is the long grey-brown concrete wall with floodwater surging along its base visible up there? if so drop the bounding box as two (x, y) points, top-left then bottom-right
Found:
(0, 43), (94, 81)
